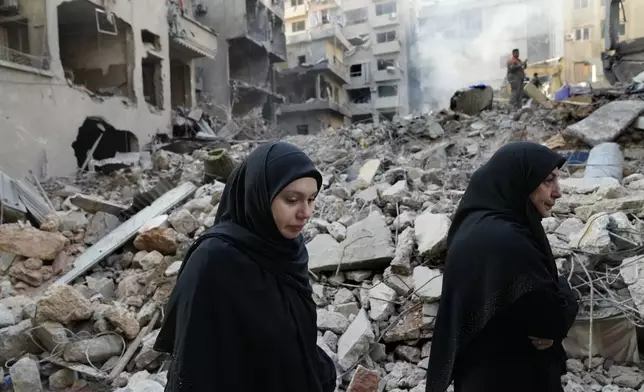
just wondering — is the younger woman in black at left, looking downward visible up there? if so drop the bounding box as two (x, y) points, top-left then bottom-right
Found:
(154, 142), (336, 392)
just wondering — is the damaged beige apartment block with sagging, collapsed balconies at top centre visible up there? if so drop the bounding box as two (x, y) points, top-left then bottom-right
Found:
(276, 0), (352, 134)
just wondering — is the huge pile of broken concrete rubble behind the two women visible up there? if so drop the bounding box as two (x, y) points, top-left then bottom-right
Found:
(0, 104), (644, 392)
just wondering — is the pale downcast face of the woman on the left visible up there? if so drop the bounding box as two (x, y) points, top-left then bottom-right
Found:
(271, 177), (318, 239)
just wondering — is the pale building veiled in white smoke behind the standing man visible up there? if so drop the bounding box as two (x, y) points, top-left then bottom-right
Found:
(412, 0), (560, 111)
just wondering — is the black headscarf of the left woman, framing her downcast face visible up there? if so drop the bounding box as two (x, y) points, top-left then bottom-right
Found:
(174, 142), (322, 290)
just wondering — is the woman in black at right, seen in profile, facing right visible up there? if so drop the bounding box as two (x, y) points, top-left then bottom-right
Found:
(426, 142), (578, 392)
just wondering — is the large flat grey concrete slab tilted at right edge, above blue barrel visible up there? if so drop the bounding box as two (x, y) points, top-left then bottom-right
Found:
(564, 100), (644, 146)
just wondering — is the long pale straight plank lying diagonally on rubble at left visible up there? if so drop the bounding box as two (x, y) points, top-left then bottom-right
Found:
(55, 182), (197, 284)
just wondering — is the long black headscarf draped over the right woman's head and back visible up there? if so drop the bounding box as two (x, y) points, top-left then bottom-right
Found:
(427, 142), (565, 392)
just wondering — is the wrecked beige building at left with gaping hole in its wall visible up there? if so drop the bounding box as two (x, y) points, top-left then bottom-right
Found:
(0, 0), (218, 178)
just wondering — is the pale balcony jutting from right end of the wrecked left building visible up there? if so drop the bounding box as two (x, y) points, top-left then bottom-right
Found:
(168, 8), (217, 59)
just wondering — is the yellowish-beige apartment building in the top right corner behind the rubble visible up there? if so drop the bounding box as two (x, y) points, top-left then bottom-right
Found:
(563, 0), (644, 83)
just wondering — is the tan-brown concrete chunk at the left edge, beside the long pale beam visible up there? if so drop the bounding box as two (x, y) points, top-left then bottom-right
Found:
(0, 223), (68, 260)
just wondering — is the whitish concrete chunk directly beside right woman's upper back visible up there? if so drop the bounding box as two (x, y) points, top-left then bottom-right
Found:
(414, 211), (452, 257)
